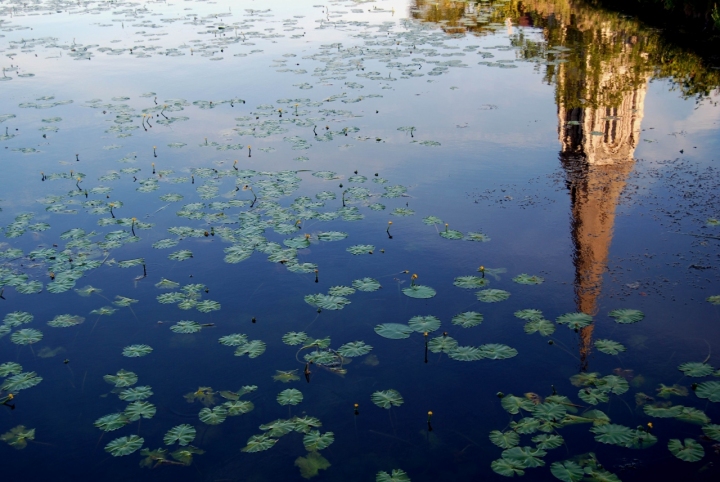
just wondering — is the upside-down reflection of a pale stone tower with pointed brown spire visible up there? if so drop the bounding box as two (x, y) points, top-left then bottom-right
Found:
(557, 57), (647, 370)
